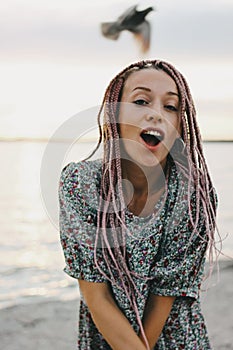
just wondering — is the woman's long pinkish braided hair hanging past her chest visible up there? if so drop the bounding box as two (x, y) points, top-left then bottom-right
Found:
(90, 60), (216, 341)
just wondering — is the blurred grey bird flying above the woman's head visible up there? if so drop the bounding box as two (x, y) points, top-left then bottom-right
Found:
(101, 6), (154, 53)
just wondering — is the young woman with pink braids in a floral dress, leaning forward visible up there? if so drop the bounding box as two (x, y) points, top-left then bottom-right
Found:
(60, 60), (216, 350)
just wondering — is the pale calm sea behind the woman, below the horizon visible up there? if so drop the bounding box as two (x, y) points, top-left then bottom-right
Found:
(0, 140), (233, 308)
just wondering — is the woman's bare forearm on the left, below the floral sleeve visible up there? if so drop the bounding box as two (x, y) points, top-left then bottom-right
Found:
(79, 280), (146, 350)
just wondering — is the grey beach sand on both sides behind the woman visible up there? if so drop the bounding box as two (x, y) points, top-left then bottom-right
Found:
(0, 261), (233, 350)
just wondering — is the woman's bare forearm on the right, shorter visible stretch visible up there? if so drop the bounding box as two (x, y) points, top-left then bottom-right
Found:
(140, 294), (175, 349)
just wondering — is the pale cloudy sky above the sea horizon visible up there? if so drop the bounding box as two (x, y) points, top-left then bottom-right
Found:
(0, 0), (233, 140)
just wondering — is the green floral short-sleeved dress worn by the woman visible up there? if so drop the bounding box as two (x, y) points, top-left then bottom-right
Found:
(59, 160), (211, 350)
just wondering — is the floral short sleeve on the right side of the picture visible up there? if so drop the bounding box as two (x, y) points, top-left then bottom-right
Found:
(150, 187), (215, 299)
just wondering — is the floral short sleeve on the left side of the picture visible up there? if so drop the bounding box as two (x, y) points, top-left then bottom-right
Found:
(59, 162), (108, 282)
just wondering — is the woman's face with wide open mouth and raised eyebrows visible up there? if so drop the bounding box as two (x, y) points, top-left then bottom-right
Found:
(119, 68), (181, 167)
